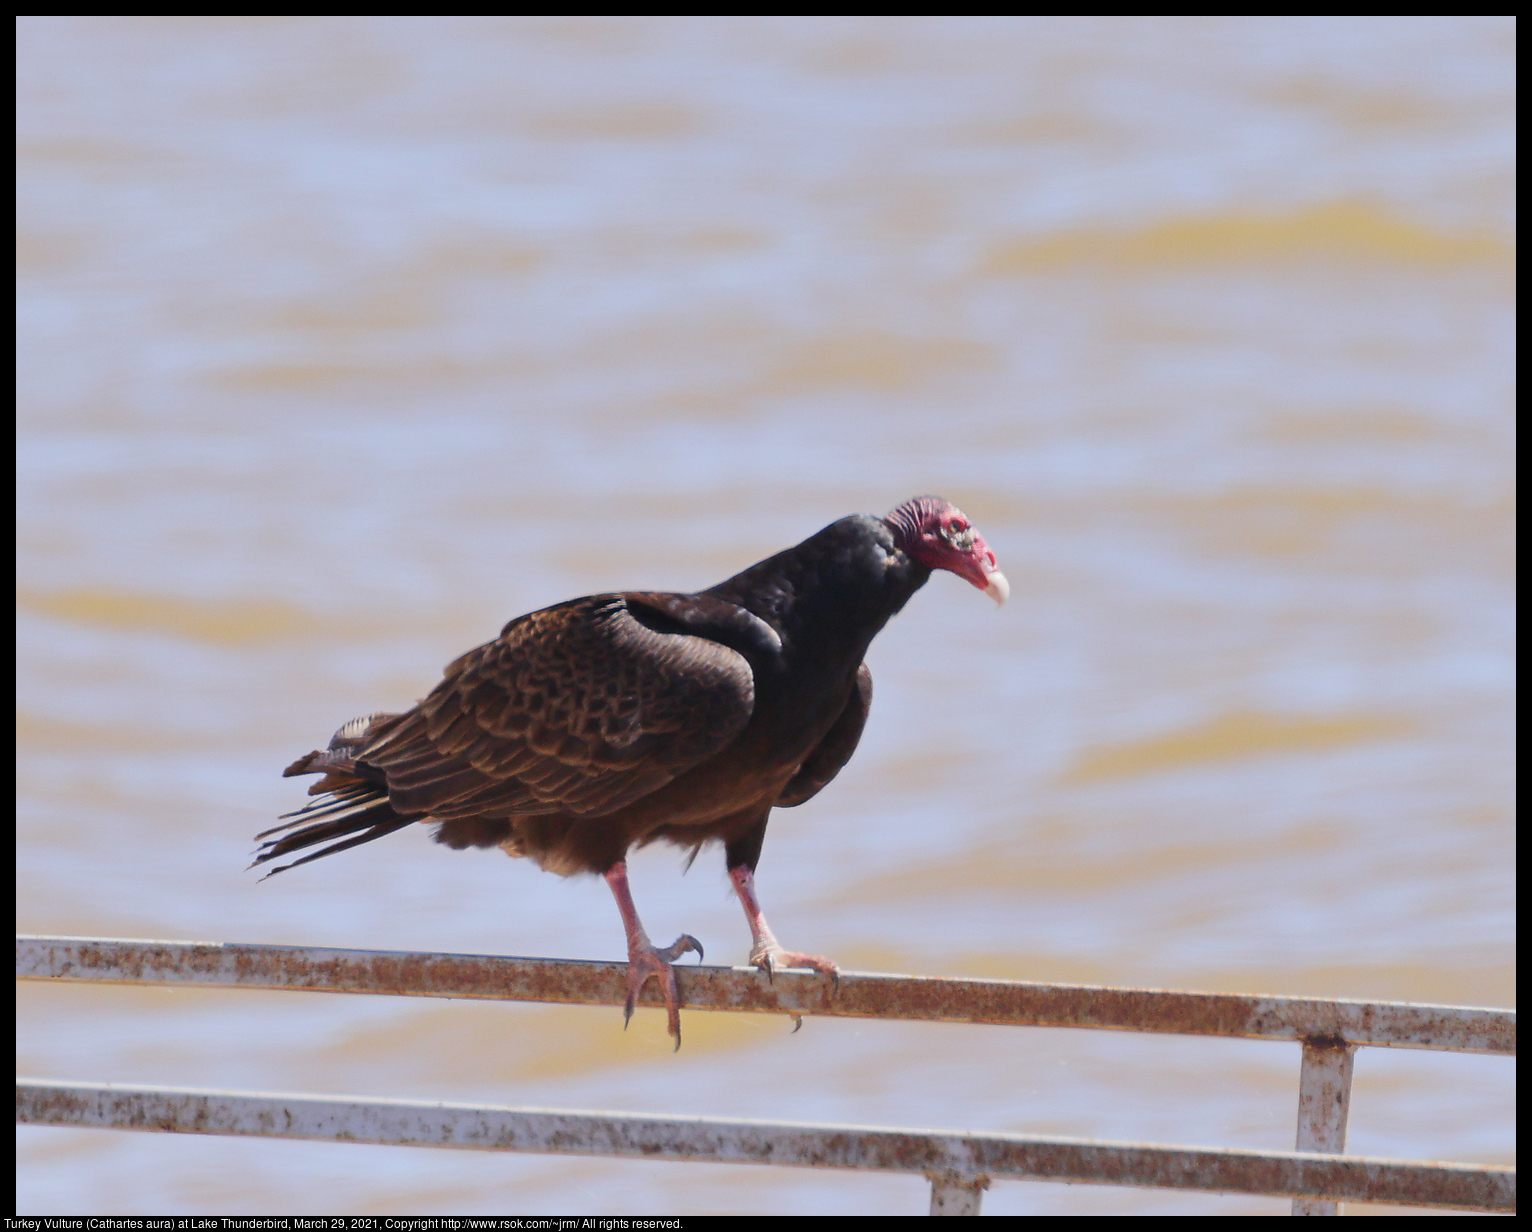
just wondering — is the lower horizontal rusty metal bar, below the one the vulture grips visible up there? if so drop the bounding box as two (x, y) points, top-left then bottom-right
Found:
(17, 1079), (1515, 1211)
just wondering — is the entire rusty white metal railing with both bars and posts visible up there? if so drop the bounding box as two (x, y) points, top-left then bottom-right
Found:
(17, 936), (1515, 1215)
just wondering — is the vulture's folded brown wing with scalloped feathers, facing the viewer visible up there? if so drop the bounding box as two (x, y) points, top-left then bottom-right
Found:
(355, 595), (755, 821)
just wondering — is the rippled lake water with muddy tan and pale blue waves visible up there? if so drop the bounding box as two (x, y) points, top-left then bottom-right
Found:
(17, 17), (1514, 1215)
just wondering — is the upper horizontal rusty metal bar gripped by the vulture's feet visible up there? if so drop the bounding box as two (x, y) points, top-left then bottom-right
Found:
(15, 936), (1515, 1054)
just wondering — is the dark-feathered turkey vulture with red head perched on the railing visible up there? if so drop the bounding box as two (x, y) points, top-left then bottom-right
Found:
(251, 496), (1010, 1048)
